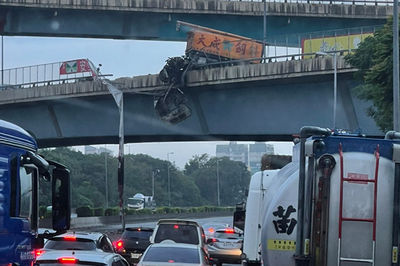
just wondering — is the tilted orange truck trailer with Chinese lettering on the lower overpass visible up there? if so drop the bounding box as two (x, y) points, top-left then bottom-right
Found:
(177, 21), (263, 65)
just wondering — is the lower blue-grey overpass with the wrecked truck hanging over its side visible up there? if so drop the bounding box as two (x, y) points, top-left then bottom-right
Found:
(0, 56), (383, 147)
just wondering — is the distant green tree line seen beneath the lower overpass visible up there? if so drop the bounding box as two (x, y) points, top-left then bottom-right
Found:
(39, 148), (250, 209)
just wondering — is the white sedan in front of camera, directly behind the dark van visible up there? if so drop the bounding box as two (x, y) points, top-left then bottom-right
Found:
(137, 240), (211, 266)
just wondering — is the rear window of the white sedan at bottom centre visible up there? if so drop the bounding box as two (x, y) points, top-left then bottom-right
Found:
(143, 247), (200, 263)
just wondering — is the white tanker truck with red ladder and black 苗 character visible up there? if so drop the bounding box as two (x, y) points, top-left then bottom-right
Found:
(244, 127), (400, 266)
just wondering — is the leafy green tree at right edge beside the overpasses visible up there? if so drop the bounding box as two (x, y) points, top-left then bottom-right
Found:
(345, 18), (393, 131)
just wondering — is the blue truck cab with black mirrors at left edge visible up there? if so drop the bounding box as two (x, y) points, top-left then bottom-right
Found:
(0, 120), (71, 266)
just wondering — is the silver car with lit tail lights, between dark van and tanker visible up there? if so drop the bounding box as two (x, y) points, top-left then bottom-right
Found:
(207, 227), (243, 266)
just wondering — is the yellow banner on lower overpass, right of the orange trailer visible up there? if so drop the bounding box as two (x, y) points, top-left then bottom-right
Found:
(301, 33), (373, 58)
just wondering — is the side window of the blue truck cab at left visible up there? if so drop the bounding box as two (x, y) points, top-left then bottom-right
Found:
(19, 167), (32, 219)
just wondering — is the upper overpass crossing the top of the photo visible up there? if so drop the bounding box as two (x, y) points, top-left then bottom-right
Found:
(0, 0), (393, 47)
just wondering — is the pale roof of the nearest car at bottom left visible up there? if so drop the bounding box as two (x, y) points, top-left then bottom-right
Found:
(37, 250), (115, 263)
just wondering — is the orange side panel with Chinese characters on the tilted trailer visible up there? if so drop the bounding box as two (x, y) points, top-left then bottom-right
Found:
(186, 31), (263, 62)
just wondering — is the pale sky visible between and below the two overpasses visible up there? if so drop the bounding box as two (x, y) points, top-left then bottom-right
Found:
(3, 37), (293, 168)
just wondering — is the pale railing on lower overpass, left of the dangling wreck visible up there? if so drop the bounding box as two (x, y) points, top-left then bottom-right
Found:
(0, 59), (110, 90)
